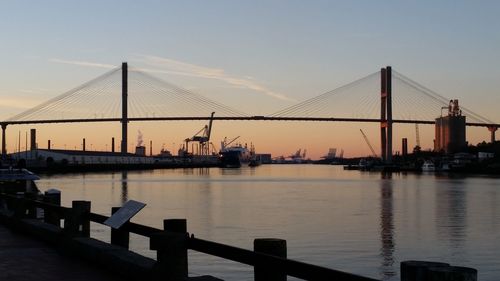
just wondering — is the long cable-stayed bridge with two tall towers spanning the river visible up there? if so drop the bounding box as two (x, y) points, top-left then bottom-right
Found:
(0, 63), (500, 162)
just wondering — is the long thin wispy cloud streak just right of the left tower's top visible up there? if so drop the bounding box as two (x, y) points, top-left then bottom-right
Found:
(138, 55), (295, 101)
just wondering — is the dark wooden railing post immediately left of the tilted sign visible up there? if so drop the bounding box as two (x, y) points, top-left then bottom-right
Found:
(64, 201), (90, 237)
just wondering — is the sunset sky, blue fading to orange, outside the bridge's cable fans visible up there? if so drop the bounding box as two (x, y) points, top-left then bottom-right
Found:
(0, 0), (500, 159)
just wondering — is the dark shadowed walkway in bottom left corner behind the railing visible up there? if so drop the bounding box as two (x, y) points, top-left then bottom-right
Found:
(0, 224), (124, 281)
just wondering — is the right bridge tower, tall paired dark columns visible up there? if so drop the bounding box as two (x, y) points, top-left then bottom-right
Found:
(380, 66), (392, 163)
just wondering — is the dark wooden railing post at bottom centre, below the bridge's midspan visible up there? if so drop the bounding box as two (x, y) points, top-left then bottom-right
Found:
(253, 238), (286, 281)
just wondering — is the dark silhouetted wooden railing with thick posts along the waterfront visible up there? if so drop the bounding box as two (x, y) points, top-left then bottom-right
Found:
(0, 190), (477, 281)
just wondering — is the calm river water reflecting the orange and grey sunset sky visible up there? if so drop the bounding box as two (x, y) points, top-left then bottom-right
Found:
(37, 165), (500, 281)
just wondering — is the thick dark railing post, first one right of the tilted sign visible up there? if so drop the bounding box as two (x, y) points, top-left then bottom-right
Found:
(150, 219), (188, 281)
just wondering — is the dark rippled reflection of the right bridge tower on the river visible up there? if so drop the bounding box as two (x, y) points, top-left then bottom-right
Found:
(380, 173), (397, 280)
